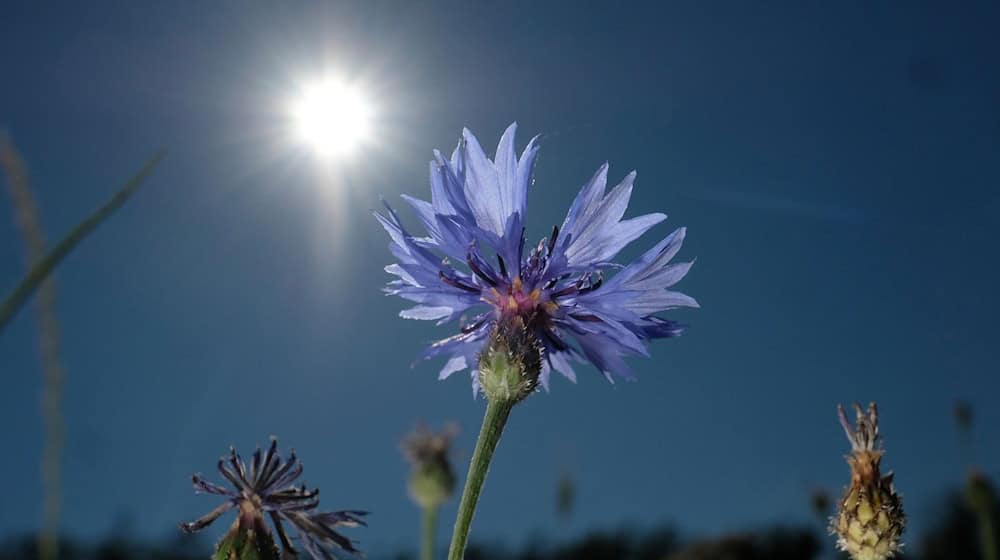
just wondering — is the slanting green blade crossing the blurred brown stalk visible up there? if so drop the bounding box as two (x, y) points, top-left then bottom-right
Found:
(0, 151), (166, 333)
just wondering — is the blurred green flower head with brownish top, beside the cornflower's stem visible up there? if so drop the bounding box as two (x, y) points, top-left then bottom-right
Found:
(401, 424), (458, 508)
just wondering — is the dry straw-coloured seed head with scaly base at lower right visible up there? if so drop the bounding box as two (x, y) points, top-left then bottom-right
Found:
(831, 403), (906, 560)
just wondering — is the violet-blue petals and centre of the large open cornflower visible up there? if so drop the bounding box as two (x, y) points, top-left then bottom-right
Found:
(375, 124), (698, 392)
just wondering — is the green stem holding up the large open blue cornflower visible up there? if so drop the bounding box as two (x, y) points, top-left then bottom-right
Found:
(448, 399), (515, 560)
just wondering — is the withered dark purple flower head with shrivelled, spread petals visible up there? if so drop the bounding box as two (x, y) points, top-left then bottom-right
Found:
(180, 438), (367, 560)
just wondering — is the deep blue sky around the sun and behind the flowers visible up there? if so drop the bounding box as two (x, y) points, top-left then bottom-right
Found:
(0, 2), (1000, 551)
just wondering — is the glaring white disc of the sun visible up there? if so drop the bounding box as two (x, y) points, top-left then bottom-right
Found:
(292, 78), (372, 156)
